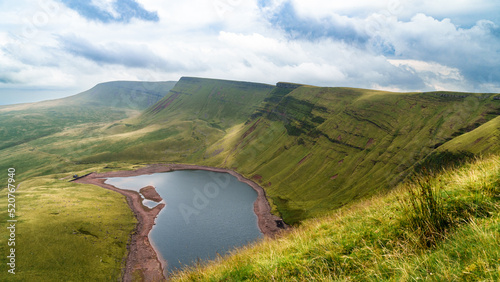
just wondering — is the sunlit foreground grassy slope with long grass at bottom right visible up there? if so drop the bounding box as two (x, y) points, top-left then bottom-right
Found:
(171, 157), (500, 281)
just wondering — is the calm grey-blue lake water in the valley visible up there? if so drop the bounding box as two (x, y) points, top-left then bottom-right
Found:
(106, 170), (263, 271)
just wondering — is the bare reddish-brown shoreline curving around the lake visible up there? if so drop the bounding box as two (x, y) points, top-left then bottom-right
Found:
(74, 164), (288, 281)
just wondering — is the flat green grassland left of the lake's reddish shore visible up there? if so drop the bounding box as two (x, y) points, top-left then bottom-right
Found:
(0, 175), (136, 281)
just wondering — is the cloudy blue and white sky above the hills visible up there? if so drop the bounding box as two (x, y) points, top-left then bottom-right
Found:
(0, 0), (500, 104)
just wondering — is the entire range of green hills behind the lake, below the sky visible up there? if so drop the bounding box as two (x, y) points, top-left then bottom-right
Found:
(0, 77), (500, 224)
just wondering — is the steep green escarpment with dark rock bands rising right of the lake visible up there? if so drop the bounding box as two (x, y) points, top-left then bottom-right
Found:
(201, 87), (500, 223)
